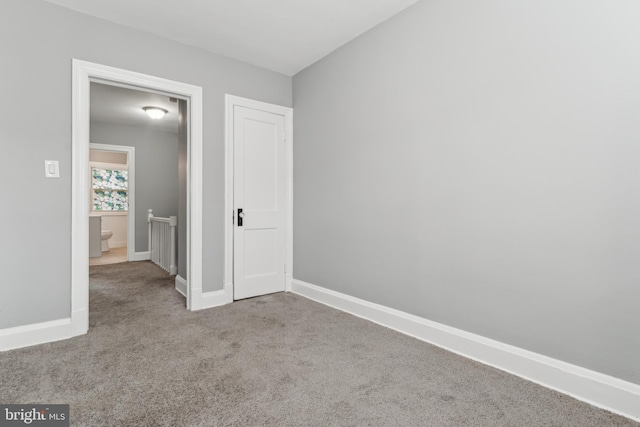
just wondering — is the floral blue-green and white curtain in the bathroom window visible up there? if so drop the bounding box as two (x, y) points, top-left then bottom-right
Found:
(92, 168), (129, 211)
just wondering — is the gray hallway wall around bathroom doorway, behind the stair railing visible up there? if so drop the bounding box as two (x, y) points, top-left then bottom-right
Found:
(90, 121), (178, 252)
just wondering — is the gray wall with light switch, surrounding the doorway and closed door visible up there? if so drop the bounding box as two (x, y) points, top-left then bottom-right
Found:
(0, 0), (291, 328)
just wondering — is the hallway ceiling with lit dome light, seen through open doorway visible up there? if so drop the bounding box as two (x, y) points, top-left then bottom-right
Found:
(90, 83), (178, 133)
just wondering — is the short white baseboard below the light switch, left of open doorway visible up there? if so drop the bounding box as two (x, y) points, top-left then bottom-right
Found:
(0, 318), (78, 351)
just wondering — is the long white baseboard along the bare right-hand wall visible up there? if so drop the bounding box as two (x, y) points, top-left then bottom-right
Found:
(291, 279), (640, 421)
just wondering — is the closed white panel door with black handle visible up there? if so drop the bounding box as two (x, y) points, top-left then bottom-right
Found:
(233, 105), (286, 299)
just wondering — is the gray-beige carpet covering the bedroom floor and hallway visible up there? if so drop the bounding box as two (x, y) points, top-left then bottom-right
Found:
(0, 262), (639, 427)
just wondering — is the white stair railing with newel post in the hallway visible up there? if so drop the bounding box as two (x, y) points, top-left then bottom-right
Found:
(147, 209), (178, 275)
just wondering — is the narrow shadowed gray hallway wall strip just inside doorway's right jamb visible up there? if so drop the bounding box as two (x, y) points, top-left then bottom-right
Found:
(177, 100), (189, 280)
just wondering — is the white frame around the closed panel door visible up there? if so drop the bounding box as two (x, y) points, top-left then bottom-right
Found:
(224, 94), (293, 303)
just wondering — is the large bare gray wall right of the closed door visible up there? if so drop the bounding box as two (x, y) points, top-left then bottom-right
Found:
(293, 0), (640, 383)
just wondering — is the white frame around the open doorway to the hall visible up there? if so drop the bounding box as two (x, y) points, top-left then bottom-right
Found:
(71, 59), (203, 336)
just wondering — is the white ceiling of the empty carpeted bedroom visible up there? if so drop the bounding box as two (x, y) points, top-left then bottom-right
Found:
(41, 0), (417, 76)
